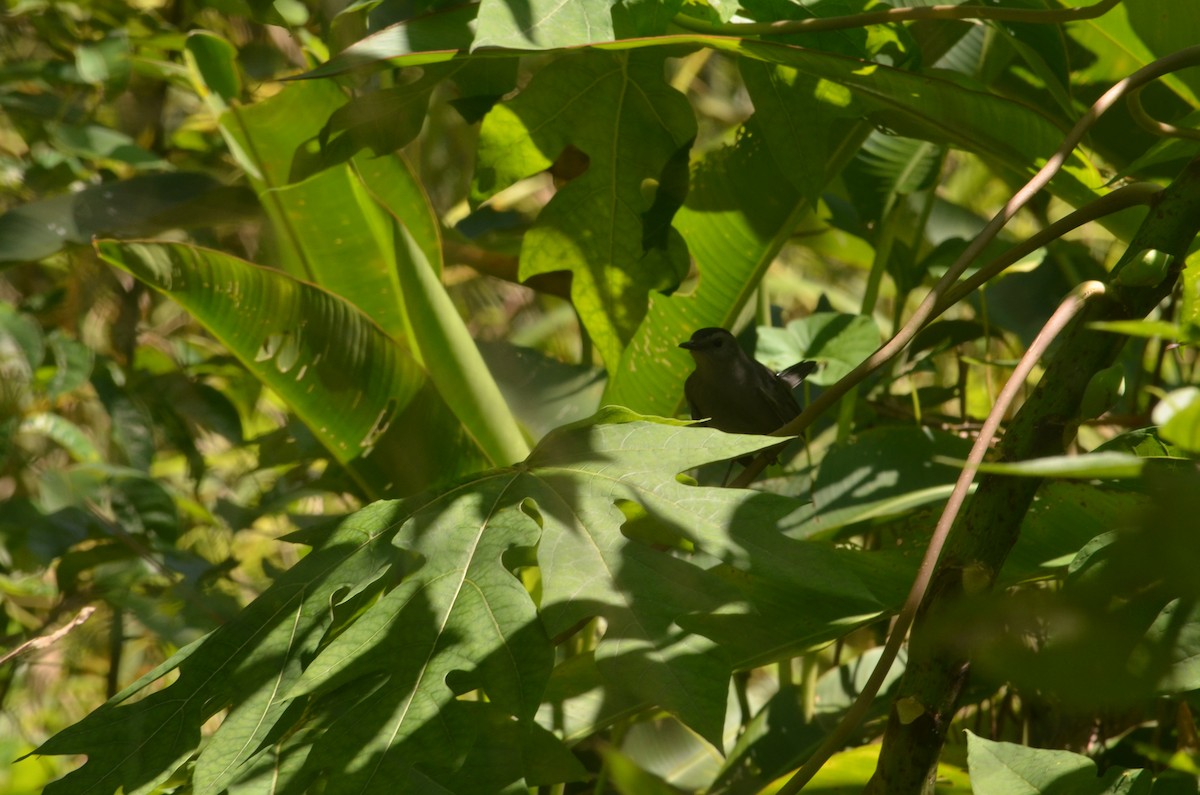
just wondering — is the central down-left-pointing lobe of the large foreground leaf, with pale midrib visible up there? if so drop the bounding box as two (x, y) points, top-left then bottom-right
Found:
(288, 470), (553, 793)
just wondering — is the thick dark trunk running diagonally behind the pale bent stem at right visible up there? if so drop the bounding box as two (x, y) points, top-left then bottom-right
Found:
(868, 159), (1200, 795)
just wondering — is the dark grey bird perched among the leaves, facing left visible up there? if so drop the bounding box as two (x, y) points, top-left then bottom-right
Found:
(679, 328), (817, 435)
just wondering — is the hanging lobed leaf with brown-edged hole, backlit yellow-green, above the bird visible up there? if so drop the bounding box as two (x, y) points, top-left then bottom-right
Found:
(473, 52), (696, 366)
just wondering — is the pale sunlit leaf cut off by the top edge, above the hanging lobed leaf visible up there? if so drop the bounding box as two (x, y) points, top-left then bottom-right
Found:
(470, 0), (616, 50)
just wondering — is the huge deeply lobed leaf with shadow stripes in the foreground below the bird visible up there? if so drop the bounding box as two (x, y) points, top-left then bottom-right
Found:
(40, 410), (895, 794)
